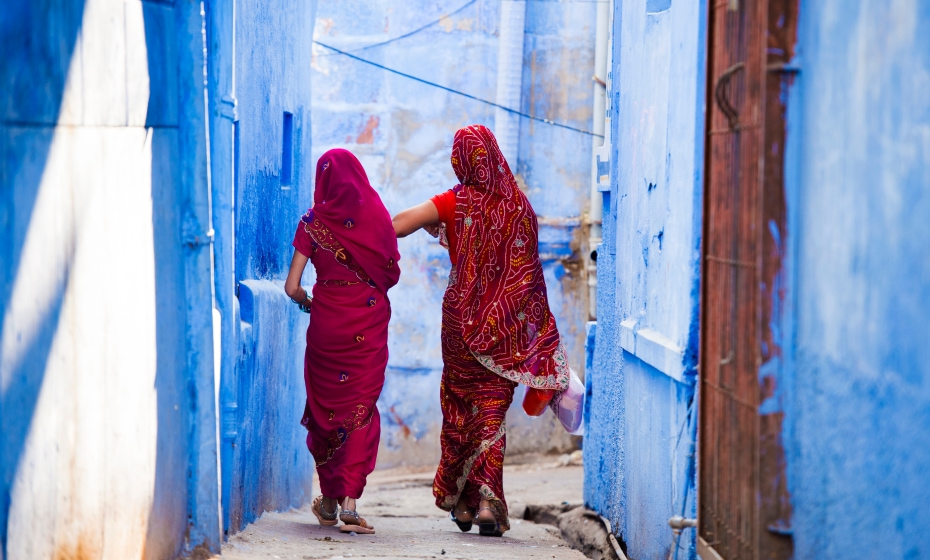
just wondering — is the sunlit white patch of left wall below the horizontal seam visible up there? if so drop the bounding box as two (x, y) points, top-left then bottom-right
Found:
(0, 124), (157, 559)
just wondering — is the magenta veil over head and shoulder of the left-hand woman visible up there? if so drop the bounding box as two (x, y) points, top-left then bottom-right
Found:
(312, 148), (400, 293)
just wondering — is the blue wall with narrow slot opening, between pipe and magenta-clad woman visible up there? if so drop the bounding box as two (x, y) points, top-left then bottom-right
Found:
(208, 0), (316, 533)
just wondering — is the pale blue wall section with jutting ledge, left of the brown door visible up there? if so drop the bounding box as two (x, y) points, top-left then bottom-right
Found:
(584, 1), (706, 558)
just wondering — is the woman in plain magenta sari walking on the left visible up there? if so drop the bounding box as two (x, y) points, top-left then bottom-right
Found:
(284, 149), (400, 532)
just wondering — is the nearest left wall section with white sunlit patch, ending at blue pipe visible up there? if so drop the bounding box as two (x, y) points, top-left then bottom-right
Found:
(0, 0), (219, 559)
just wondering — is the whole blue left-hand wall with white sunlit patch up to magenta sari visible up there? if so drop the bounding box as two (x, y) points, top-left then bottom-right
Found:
(0, 0), (315, 558)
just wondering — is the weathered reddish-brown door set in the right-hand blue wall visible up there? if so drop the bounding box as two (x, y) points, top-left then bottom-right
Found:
(698, 0), (798, 560)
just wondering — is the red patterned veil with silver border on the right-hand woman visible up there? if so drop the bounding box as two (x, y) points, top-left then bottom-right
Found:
(444, 125), (569, 390)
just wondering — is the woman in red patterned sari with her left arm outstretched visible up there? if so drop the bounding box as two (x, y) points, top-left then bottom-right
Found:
(394, 125), (569, 536)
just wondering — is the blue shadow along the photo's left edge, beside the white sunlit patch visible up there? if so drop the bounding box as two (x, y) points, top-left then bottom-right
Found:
(0, 0), (84, 556)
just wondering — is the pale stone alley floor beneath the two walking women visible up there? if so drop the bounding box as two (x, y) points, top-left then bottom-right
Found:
(217, 457), (585, 560)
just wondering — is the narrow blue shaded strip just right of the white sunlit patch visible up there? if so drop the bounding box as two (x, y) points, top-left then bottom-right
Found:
(142, 2), (191, 558)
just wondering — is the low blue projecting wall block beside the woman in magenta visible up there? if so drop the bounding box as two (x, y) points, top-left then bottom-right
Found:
(223, 280), (313, 532)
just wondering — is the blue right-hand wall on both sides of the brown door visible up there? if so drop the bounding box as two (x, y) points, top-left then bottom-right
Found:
(585, 0), (930, 558)
